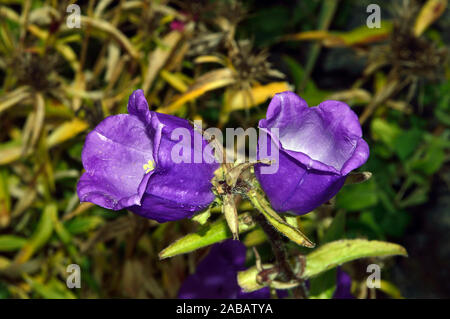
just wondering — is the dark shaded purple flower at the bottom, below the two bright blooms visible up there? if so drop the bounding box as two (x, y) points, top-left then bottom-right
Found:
(178, 239), (270, 299)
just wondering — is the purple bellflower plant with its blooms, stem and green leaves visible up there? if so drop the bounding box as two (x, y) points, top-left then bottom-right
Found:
(77, 90), (406, 298)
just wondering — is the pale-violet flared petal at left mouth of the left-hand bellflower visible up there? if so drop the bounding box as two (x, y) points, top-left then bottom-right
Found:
(77, 114), (154, 210)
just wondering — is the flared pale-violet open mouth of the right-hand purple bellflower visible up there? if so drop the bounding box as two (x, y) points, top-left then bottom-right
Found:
(259, 92), (369, 174)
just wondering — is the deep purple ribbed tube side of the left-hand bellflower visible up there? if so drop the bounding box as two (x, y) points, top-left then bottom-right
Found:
(132, 113), (219, 222)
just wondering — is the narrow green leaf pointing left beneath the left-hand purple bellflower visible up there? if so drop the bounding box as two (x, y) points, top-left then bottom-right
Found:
(159, 213), (255, 259)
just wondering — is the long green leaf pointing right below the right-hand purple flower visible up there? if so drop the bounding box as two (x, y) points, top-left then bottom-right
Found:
(303, 239), (408, 278)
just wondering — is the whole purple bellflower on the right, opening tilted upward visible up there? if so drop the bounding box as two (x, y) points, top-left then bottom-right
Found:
(255, 92), (369, 215)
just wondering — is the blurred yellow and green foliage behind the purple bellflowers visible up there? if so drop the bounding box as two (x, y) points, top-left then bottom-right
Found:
(0, 0), (450, 298)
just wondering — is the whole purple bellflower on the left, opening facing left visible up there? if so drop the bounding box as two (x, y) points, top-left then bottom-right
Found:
(77, 90), (219, 222)
